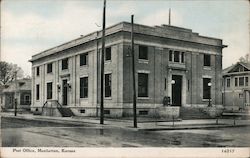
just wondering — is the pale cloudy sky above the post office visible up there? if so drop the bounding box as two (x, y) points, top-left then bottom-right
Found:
(0, 0), (250, 75)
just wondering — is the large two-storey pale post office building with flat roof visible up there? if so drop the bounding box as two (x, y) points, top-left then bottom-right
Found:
(30, 22), (225, 117)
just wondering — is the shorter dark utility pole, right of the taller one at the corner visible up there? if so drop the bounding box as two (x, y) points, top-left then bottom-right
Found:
(131, 15), (137, 128)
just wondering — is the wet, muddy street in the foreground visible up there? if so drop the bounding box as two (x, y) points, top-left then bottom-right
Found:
(1, 118), (250, 147)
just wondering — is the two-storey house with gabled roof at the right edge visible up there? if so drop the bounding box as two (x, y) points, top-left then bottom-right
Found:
(223, 62), (250, 110)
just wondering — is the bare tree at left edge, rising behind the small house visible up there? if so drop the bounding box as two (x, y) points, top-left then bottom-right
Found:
(0, 61), (24, 85)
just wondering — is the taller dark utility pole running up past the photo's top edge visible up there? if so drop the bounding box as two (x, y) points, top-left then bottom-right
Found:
(100, 0), (106, 124)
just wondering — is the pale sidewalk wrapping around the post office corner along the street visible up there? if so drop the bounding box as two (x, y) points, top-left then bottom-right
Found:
(1, 112), (250, 131)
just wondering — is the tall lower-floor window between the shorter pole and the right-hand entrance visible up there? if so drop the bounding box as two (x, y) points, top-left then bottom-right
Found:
(138, 73), (148, 97)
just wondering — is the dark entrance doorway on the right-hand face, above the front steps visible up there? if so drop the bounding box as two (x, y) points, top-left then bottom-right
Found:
(172, 75), (182, 106)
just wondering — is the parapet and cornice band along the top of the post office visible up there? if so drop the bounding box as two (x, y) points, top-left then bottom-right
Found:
(29, 22), (226, 62)
